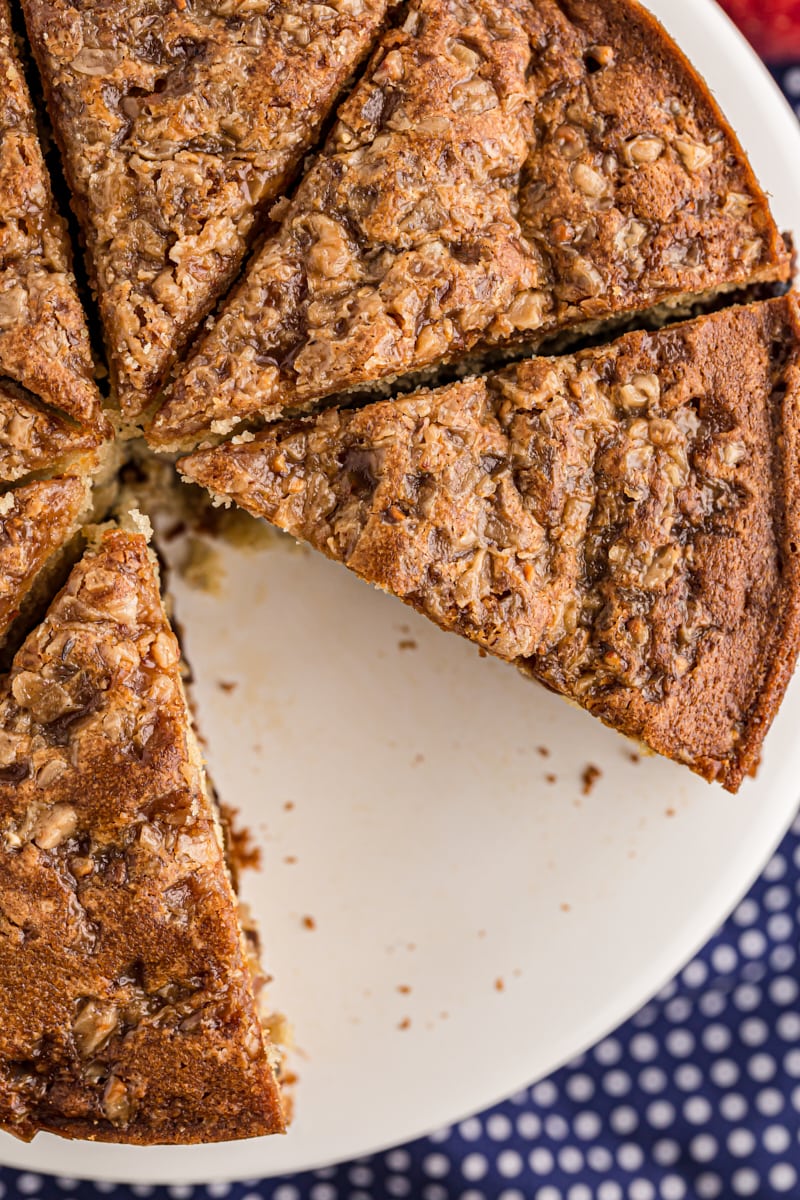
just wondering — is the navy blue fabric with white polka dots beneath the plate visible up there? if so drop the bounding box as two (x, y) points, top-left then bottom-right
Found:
(0, 817), (800, 1200)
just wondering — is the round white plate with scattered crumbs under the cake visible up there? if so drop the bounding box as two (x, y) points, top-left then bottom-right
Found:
(0, 0), (800, 1183)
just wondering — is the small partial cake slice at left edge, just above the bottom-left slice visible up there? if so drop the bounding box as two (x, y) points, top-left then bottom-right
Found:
(0, 475), (91, 666)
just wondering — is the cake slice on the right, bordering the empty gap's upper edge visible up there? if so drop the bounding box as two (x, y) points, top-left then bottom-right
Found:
(181, 295), (800, 791)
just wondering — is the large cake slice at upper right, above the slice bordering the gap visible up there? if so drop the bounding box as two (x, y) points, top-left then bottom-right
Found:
(150, 0), (789, 449)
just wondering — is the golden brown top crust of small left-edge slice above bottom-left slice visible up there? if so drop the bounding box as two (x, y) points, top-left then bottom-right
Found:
(0, 475), (88, 646)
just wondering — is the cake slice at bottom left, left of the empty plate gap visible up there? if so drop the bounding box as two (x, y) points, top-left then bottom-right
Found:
(0, 520), (283, 1144)
